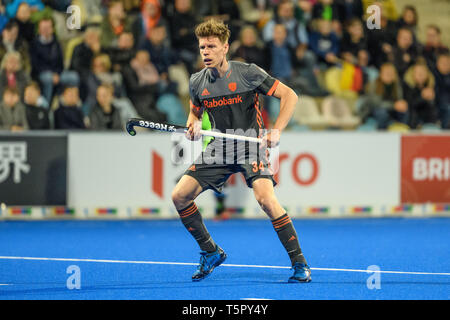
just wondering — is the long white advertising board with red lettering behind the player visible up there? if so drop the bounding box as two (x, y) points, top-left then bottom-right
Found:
(68, 132), (400, 211)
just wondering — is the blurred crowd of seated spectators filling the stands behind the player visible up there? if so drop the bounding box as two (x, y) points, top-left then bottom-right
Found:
(0, 0), (450, 131)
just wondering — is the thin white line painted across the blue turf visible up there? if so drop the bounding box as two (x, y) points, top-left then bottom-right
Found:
(0, 256), (450, 276)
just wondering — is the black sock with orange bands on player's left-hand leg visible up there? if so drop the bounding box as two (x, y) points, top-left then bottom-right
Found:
(178, 202), (216, 252)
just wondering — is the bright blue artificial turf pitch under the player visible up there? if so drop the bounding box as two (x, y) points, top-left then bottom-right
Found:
(0, 218), (450, 300)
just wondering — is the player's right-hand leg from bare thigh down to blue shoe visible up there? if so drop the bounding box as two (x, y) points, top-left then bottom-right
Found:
(252, 178), (311, 282)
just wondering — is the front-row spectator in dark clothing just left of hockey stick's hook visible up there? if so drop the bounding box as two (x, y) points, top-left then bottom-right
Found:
(89, 84), (122, 130)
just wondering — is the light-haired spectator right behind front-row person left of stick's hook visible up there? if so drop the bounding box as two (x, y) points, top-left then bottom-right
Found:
(83, 53), (124, 115)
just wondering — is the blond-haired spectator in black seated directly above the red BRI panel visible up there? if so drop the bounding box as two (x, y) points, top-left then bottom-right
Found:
(403, 59), (438, 129)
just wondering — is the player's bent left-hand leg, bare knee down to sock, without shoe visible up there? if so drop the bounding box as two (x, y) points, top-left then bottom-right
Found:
(172, 175), (216, 252)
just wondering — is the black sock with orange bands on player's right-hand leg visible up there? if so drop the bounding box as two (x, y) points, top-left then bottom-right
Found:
(272, 213), (307, 265)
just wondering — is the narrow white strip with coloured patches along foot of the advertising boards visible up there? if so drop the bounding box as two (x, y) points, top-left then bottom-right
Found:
(0, 203), (450, 220)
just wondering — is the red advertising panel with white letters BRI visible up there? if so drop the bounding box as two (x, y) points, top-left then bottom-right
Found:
(401, 135), (450, 203)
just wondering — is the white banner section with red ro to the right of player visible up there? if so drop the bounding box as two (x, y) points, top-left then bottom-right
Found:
(268, 132), (400, 205)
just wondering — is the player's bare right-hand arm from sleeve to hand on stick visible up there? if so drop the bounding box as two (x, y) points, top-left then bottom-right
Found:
(262, 82), (298, 148)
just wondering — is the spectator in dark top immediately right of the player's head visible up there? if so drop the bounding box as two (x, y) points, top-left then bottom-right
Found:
(232, 25), (268, 69)
